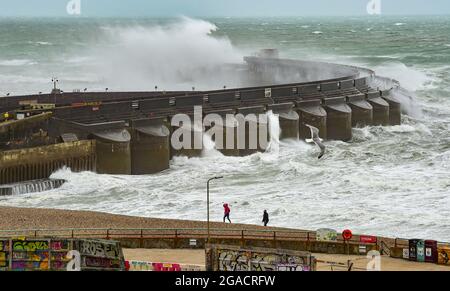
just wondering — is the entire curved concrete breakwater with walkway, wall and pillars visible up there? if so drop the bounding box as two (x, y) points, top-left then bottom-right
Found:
(0, 58), (401, 184)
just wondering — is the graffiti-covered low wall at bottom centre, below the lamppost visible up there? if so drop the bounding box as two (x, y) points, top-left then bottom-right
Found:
(216, 248), (314, 271)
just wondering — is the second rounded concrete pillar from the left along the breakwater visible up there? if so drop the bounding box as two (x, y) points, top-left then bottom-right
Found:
(131, 119), (170, 175)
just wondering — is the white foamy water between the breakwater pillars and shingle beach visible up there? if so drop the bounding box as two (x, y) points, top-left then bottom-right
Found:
(2, 117), (450, 240)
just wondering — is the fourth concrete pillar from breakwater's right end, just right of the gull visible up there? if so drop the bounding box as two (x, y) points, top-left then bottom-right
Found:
(323, 97), (352, 141)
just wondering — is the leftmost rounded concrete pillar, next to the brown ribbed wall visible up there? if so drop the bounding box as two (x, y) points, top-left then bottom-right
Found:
(93, 129), (131, 175)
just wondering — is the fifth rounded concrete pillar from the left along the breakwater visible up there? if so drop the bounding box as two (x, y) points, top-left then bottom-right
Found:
(236, 106), (269, 156)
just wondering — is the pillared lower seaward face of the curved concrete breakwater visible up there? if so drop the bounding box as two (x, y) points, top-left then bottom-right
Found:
(0, 92), (401, 184)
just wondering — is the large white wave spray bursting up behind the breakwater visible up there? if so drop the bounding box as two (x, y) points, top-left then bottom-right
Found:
(95, 17), (243, 90)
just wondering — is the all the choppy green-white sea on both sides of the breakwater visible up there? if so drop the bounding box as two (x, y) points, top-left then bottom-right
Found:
(0, 16), (450, 241)
